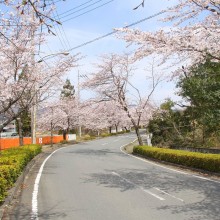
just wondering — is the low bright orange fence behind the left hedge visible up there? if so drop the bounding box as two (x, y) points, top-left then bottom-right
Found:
(0, 135), (63, 150)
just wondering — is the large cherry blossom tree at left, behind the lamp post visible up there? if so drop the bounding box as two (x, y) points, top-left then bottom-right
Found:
(0, 12), (78, 131)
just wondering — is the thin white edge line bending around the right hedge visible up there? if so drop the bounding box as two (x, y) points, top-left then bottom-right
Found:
(120, 139), (220, 184)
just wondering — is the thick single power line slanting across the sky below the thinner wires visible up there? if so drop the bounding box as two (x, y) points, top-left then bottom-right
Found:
(68, 11), (165, 51)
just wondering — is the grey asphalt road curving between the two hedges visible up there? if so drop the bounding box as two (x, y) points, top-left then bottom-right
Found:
(6, 131), (220, 220)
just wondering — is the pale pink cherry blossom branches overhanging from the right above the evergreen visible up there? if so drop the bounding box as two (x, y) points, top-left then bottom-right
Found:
(118, 0), (220, 75)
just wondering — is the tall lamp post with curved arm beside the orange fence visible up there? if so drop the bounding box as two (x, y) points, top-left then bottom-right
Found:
(31, 52), (69, 144)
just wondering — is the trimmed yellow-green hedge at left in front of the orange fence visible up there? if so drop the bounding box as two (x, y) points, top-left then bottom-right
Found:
(0, 145), (41, 202)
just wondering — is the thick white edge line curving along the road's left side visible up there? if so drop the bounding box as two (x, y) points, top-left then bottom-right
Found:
(31, 147), (66, 220)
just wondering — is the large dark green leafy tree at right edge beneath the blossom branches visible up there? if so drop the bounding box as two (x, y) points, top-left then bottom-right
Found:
(177, 60), (220, 144)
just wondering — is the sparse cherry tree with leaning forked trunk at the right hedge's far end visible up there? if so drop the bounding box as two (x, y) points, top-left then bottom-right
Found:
(84, 54), (160, 145)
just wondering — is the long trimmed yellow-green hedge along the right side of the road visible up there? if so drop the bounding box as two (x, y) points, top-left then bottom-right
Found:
(133, 146), (220, 173)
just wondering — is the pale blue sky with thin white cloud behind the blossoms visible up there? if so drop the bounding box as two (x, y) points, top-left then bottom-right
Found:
(42, 0), (180, 104)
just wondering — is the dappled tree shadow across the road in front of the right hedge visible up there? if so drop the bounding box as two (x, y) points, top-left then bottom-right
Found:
(83, 168), (220, 220)
